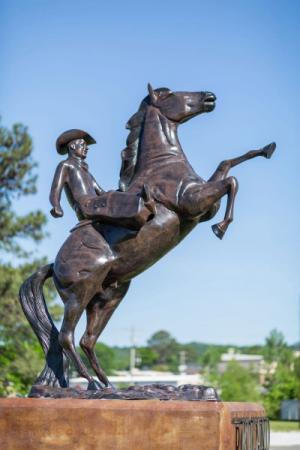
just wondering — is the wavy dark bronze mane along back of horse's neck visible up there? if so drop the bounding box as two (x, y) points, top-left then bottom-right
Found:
(119, 88), (170, 191)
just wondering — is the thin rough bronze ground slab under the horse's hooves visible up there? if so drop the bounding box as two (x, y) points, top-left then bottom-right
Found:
(29, 384), (220, 401)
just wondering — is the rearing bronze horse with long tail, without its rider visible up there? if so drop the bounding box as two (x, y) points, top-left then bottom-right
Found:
(20, 85), (275, 389)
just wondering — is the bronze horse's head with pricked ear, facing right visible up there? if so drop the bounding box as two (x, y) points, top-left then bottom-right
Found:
(145, 84), (216, 124)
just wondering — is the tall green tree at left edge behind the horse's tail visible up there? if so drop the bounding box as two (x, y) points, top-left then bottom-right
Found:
(0, 118), (61, 395)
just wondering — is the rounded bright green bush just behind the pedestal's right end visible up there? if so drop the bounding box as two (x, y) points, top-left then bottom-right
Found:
(216, 361), (260, 402)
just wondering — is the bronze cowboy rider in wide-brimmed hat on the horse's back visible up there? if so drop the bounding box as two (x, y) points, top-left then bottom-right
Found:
(50, 129), (155, 229)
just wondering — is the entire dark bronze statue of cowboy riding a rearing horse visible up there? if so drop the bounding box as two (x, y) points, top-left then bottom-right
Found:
(20, 85), (276, 400)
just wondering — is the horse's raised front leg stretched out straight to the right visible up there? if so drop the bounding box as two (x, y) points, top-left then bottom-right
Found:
(208, 142), (276, 182)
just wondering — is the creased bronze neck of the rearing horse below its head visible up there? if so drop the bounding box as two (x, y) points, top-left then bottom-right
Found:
(136, 106), (187, 173)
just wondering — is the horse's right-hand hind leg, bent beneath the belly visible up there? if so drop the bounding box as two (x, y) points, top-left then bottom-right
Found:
(80, 282), (130, 386)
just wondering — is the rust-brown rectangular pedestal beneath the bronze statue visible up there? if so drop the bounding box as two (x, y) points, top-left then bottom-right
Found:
(0, 398), (269, 450)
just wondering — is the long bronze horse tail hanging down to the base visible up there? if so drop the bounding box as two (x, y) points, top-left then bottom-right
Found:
(19, 264), (68, 387)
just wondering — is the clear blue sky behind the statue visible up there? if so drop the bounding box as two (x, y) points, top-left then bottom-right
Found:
(0, 0), (300, 345)
